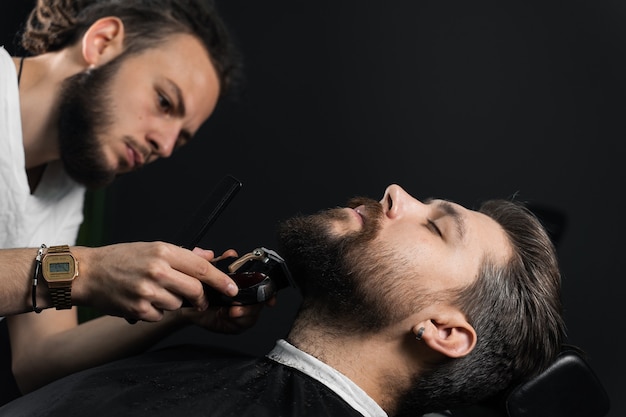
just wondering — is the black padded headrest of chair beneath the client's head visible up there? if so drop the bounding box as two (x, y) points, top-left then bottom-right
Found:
(450, 346), (610, 417)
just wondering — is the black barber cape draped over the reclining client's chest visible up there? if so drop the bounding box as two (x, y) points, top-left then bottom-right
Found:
(0, 346), (362, 417)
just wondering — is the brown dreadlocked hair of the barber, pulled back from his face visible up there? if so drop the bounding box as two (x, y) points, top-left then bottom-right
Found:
(22, 0), (239, 92)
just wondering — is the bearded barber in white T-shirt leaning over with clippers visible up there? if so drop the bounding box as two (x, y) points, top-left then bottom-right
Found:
(0, 0), (260, 393)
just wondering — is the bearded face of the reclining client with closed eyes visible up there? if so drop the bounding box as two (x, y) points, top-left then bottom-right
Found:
(280, 185), (509, 330)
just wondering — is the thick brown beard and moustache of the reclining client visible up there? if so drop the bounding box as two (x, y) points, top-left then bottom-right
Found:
(278, 198), (415, 332)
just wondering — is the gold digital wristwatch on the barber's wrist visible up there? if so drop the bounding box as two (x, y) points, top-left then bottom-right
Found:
(41, 245), (78, 310)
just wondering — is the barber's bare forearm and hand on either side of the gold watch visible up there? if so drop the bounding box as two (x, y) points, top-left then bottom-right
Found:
(0, 242), (237, 321)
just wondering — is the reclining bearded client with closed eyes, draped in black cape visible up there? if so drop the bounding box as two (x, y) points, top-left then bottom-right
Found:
(0, 185), (564, 417)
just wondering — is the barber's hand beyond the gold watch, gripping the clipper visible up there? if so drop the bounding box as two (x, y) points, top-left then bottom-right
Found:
(72, 242), (238, 321)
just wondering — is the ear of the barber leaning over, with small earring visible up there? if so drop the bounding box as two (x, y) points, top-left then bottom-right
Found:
(82, 16), (124, 67)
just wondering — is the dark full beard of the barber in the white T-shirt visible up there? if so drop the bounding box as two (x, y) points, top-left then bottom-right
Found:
(58, 60), (121, 188)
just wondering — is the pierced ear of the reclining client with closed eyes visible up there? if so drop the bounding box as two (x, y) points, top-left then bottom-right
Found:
(413, 311), (476, 358)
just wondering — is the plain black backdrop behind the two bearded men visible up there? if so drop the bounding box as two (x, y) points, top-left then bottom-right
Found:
(0, 0), (626, 417)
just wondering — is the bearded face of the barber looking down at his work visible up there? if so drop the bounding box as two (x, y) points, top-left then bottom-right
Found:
(59, 34), (219, 186)
